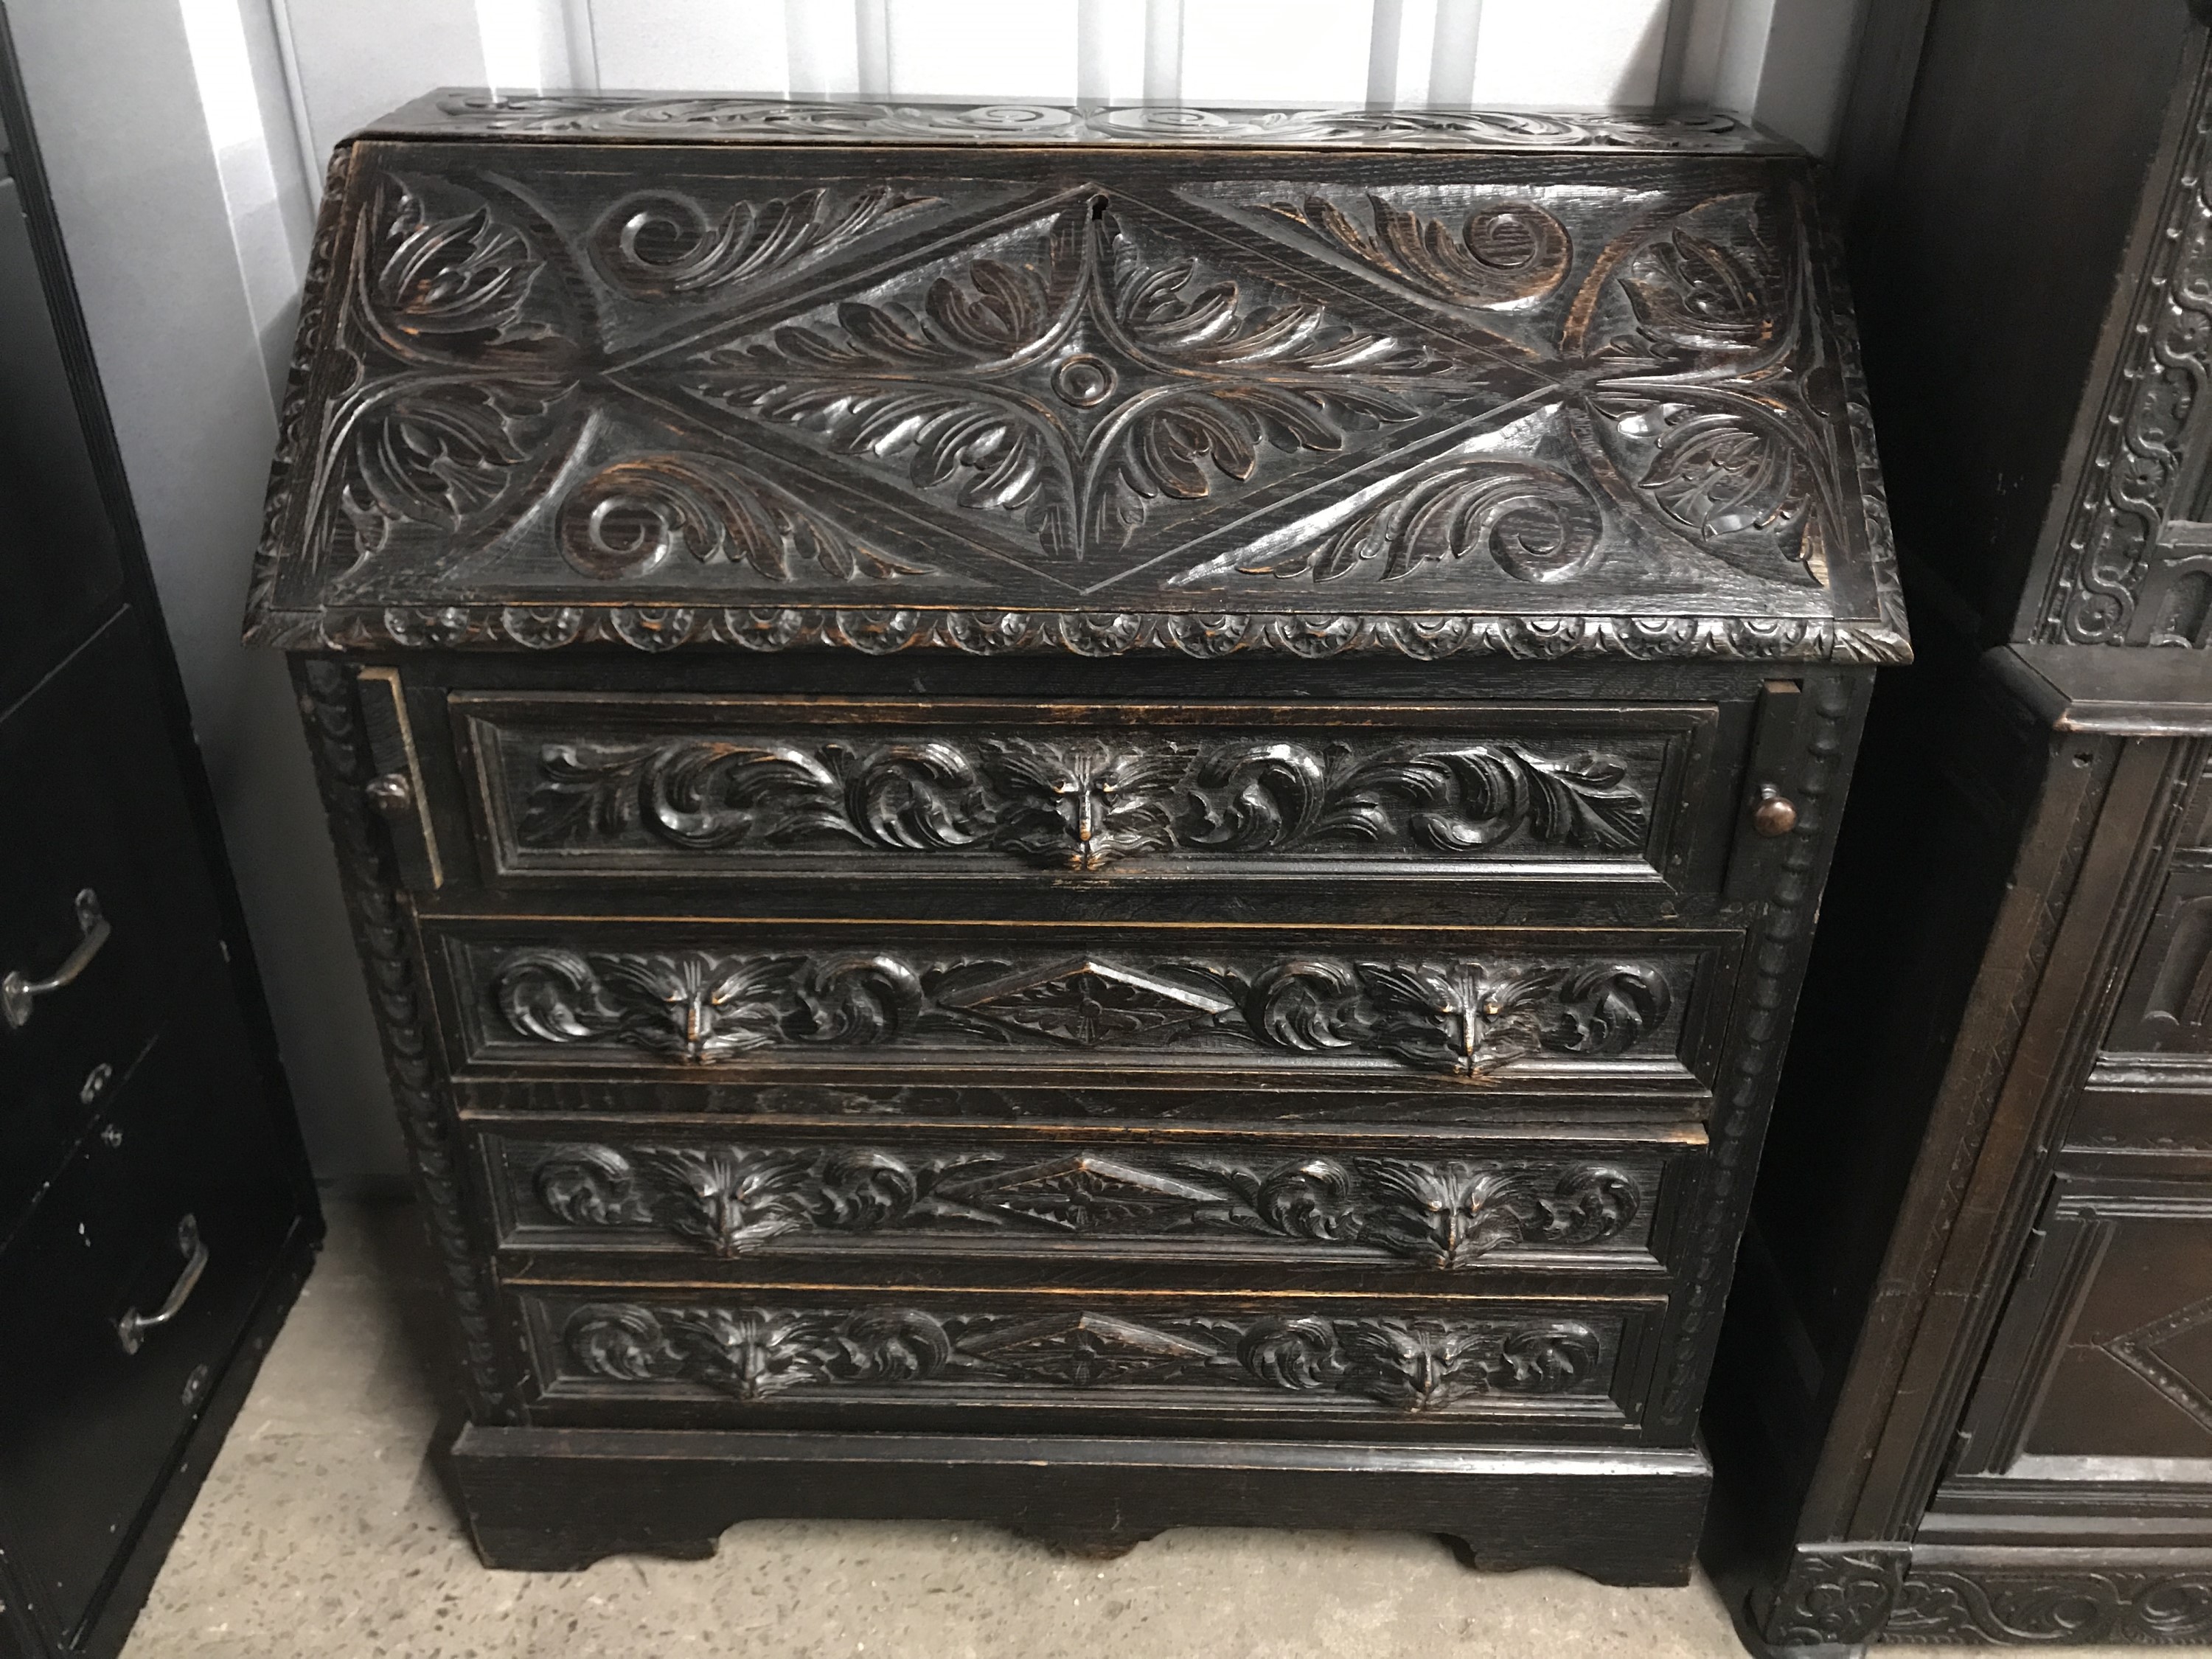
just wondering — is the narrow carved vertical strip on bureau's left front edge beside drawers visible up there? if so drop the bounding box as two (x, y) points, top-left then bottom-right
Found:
(294, 659), (515, 1422)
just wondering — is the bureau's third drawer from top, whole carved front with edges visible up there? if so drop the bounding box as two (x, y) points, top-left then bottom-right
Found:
(476, 1119), (1703, 1283)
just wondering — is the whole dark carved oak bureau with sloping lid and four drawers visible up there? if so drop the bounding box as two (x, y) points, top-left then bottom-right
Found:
(237, 93), (1907, 1582)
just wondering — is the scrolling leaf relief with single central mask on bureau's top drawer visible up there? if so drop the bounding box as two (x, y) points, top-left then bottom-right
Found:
(515, 734), (1657, 869)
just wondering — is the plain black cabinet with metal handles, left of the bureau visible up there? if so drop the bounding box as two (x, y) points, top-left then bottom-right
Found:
(0, 18), (323, 1659)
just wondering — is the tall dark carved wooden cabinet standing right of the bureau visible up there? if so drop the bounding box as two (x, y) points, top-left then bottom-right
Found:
(1708, 0), (2212, 1652)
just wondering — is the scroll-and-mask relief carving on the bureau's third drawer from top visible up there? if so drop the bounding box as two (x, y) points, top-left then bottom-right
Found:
(529, 1144), (1644, 1272)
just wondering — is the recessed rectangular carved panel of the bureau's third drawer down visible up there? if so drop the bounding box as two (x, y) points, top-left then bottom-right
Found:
(489, 1135), (1668, 1272)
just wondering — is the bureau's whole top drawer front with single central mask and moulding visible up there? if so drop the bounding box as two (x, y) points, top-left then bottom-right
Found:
(453, 695), (1717, 878)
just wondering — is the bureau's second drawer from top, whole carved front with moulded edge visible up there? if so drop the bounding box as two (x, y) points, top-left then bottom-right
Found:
(425, 918), (1739, 1093)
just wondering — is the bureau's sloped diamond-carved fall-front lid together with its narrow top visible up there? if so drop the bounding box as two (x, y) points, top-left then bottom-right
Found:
(248, 93), (1907, 661)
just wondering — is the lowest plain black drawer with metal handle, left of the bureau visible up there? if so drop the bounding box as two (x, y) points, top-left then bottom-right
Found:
(0, 1035), (294, 1644)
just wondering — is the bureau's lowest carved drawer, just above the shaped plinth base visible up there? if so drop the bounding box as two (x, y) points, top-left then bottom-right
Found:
(509, 1283), (1666, 1440)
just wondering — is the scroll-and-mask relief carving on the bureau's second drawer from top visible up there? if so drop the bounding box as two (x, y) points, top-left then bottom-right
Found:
(484, 947), (1674, 1079)
